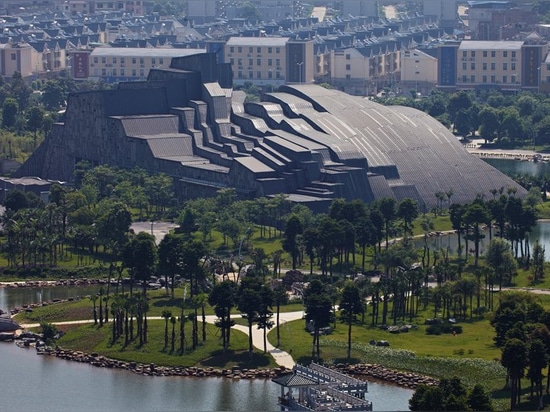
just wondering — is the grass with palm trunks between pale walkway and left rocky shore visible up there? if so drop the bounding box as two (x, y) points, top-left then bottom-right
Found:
(57, 320), (276, 369)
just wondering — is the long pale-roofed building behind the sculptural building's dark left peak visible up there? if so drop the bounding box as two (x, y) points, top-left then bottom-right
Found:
(85, 47), (206, 82)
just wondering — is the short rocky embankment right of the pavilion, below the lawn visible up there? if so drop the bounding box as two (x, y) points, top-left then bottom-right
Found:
(336, 363), (439, 389)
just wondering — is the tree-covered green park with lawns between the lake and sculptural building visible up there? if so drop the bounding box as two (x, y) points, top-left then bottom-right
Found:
(0, 166), (550, 410)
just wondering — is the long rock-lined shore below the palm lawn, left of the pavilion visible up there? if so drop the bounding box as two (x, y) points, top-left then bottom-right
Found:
(39, 347), (289, 379)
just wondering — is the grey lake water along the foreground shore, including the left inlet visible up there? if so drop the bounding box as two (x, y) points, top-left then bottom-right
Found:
(0, 288), (413, 412)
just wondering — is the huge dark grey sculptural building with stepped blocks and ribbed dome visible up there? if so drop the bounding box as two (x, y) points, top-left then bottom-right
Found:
(17, 53), (525, 210)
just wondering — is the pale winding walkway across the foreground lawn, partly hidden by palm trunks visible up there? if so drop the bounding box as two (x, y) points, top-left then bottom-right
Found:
(21, 311), (304, 369)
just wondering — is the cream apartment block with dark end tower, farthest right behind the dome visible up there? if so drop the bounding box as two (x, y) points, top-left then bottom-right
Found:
(456, 41), (523, 90)
